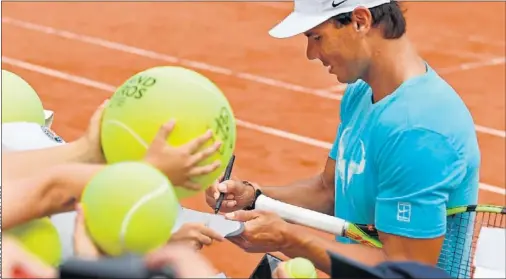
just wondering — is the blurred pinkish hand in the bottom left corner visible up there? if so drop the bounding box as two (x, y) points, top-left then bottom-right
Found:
(2, 236), (57, 278)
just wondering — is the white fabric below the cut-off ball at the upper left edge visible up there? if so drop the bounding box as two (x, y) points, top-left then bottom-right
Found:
(2, 122), (65, 152)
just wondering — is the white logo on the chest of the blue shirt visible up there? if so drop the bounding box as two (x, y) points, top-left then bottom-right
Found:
(336, 128), (366, 195)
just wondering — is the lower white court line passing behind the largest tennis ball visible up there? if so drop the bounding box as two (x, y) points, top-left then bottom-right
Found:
(2, 56), (506, 196)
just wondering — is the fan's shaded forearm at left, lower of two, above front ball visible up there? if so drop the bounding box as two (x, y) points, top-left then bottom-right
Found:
(2, 163), (105, 229)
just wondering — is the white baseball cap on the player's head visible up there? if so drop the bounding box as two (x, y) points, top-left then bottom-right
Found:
(269, 0), (392, 38)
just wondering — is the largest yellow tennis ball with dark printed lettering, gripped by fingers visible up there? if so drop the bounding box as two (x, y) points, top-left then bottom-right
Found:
(101, 66), (236, 199)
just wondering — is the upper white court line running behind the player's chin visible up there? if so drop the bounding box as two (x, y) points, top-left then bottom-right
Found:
(2, 17), (506, 138)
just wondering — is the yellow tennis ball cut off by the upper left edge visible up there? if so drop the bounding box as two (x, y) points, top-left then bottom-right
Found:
(2, 70), (45, 125)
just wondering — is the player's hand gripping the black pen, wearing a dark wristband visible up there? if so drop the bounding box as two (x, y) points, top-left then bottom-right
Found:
(206, 180), (259, 212)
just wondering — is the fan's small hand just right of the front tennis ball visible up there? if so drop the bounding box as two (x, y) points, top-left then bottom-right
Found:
(169, 223), (224, 250)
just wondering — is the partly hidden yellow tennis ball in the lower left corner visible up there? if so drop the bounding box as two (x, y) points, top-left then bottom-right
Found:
(5, 217), (62, 266)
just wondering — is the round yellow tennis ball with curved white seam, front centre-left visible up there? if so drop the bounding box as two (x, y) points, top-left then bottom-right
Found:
(81, 162), (179, 256)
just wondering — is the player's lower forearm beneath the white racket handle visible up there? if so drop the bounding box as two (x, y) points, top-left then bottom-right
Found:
(280, 228), (387, 274)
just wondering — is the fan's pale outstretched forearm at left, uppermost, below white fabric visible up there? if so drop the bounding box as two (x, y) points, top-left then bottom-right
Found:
(2, 140), (99, 180)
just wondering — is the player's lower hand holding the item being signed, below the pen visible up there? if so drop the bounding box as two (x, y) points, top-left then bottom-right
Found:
(225, 210), (293, 253)
